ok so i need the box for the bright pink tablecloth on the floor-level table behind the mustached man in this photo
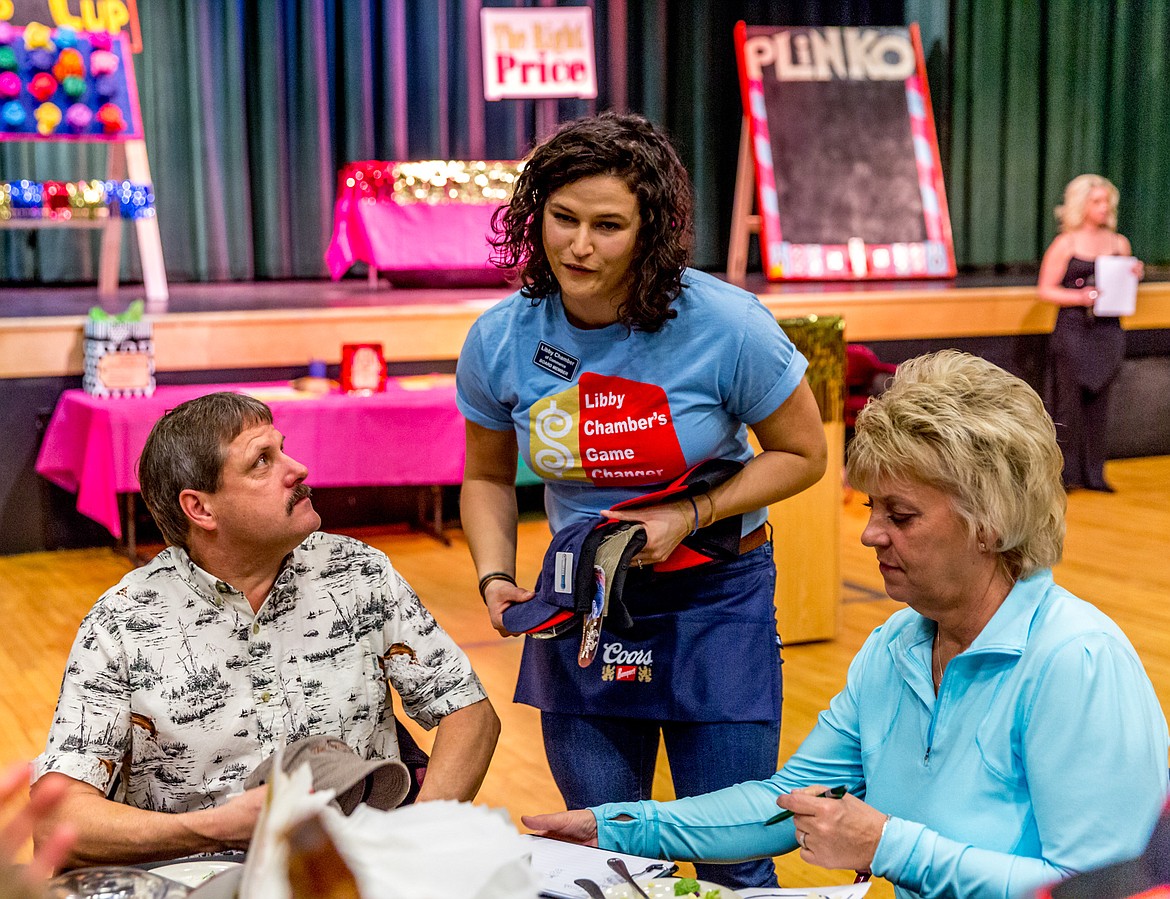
[36,375,464,537]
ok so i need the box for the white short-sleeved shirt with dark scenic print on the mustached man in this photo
[34,533,487,812]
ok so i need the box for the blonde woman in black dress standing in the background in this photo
[1038,174,1143,493]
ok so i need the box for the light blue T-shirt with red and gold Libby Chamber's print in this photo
[456,269,807,534]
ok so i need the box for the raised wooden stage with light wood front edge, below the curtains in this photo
[0,266,1170,379]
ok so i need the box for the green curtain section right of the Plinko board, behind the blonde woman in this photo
[950,0,1170,266]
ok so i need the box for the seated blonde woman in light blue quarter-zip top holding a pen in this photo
[524,351,1168,899]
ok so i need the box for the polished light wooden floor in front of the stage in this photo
[0,457,1170,897]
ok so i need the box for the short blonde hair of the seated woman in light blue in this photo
[846,350,1066,579]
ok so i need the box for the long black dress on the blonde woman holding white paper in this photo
[1048,256,1126,490]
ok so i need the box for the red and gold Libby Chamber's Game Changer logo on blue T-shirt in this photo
[529,372,686,487]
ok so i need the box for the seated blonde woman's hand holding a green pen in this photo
[776,785,887,871]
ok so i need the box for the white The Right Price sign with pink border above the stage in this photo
[480,6,597,99]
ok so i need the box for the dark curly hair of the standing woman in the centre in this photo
[490,112,695,331]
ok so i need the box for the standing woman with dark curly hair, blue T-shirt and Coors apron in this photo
[457,114,826,886]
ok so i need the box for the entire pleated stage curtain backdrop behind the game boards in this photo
[0,0,1170,282]
